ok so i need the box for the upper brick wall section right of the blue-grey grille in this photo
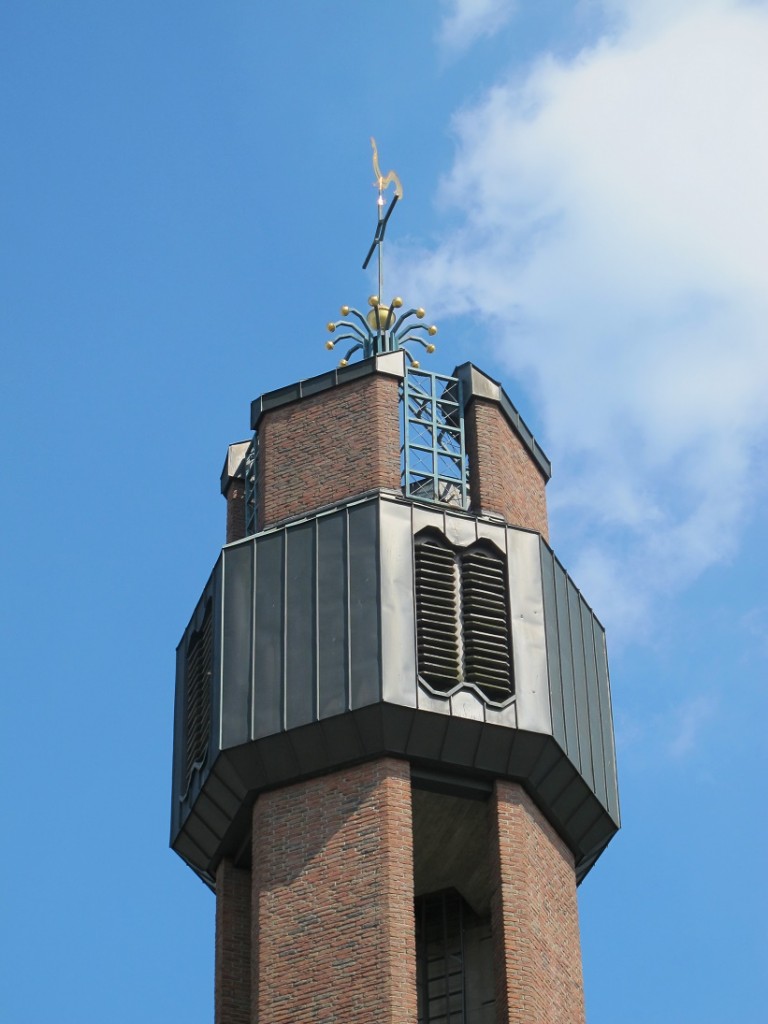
[465,398,549,539]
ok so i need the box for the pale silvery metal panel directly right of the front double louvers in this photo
[507,529,552,733]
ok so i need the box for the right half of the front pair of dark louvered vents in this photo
[462,549,512,700]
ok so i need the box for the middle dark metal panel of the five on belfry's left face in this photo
[286,520,316,729]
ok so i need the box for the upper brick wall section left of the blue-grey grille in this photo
[258,374,400,528]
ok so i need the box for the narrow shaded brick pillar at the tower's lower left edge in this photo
[214,859,251,1024]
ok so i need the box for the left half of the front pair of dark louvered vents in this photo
[416,541,461,689]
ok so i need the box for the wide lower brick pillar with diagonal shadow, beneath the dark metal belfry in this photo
[253,759,417,1024]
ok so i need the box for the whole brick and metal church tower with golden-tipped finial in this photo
[171,149,620,1024]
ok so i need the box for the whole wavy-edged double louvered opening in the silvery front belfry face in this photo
[414,530,514,701]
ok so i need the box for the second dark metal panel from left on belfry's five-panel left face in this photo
[253,530,285,739]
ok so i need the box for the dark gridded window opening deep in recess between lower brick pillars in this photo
[416,889,466,1024]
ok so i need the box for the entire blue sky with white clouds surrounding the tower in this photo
[0,0,768,1024]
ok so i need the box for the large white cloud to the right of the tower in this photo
[408,0,768,631]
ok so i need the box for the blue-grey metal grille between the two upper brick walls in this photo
[402,368,468,508]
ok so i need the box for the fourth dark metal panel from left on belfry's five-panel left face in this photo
[317,512,348,718]
